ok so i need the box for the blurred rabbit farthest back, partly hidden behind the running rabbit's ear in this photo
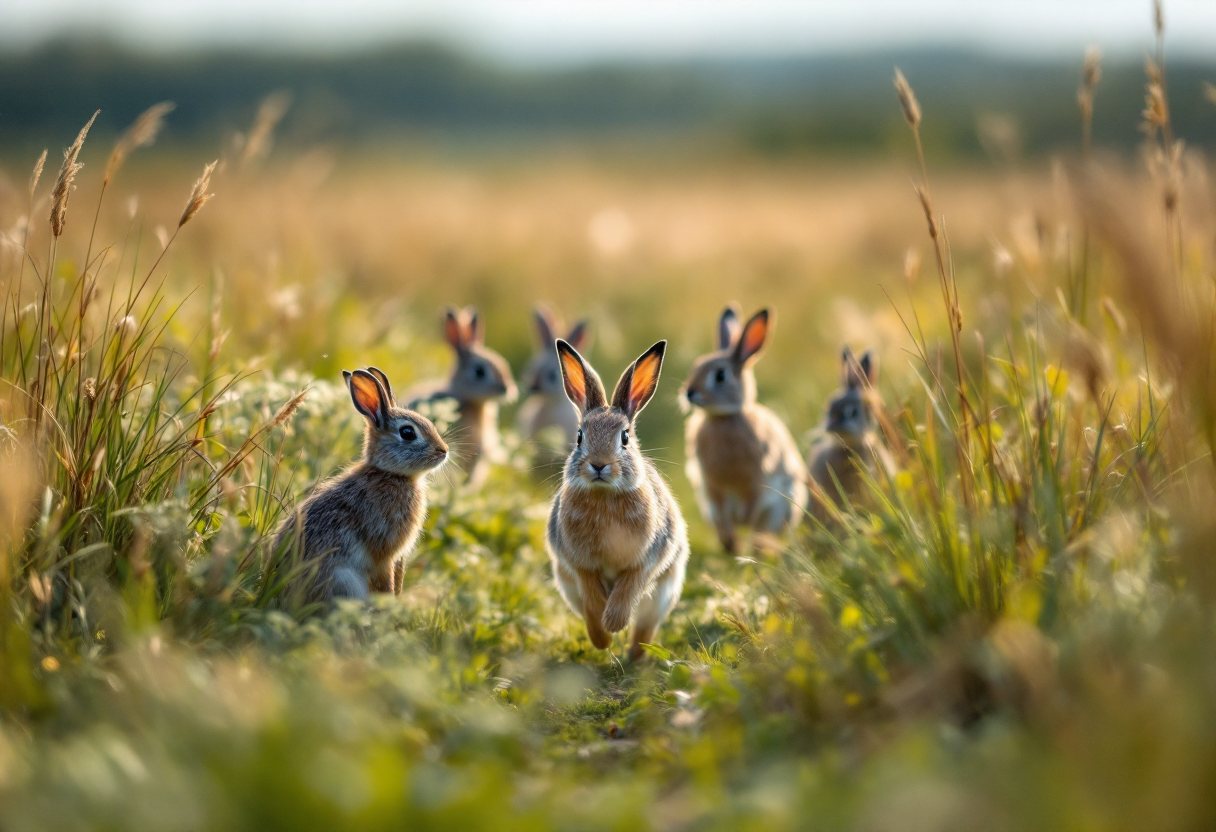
[516,305,587,459]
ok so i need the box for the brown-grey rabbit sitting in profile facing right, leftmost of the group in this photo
[275,367,447,601]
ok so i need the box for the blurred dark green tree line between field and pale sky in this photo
[0,40,1216,158]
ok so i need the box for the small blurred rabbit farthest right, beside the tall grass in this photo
[807,345,895,519]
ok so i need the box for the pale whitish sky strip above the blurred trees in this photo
[0,0,1216,63]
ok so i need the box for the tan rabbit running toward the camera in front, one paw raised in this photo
[546,341,688,659]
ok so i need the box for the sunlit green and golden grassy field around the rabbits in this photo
[0,48,1216,831]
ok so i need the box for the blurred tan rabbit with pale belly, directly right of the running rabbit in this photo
[681,305,806,555]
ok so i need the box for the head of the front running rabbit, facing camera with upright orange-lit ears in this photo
[557,339,668,491]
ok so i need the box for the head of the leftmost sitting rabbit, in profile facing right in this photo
[342,367,447,477]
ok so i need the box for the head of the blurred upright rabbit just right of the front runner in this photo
[680,304,772,416]
